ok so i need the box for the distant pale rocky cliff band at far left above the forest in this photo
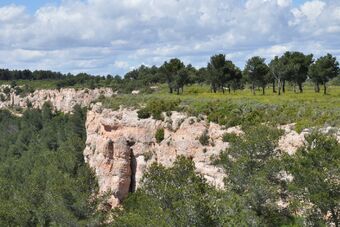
[0,86,113,113]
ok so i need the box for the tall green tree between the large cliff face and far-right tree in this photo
[216,125,295,226]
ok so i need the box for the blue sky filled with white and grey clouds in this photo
[0,0,340,75]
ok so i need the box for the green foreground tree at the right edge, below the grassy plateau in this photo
[284,133,340,226]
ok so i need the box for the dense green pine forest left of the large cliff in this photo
[0,104,106,226]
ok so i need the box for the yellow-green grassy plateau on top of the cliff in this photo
[101,85,340,131]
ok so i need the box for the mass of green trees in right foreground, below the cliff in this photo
[112,126,340,226]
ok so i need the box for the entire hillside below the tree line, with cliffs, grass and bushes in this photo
[0,81,340,226]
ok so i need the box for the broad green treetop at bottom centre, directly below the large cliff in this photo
[112,157,260,226]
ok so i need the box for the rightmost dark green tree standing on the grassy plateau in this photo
[309,54,339,94]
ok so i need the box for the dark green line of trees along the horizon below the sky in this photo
[0,52,340,95]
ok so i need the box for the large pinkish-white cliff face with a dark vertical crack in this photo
[84,104,228,207]
